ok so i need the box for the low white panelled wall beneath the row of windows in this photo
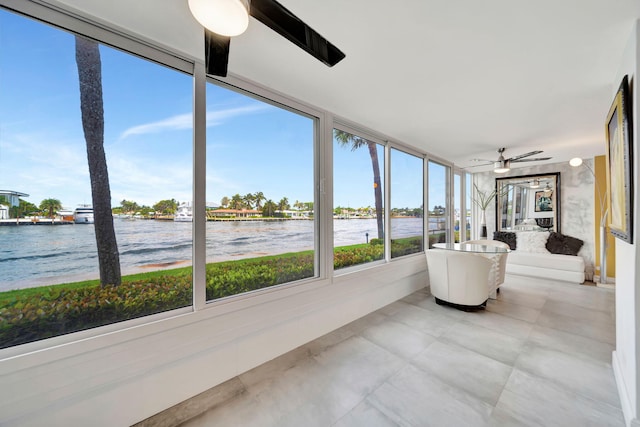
[0,254,427,427]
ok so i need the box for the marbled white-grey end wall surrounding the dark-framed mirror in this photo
[474,161,596,266]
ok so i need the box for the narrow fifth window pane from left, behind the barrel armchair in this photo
[428,161,449,248]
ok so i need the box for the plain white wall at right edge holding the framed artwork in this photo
[611,18,640,426]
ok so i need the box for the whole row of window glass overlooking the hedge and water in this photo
[0,2,449,348]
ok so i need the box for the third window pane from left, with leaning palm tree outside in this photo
[333,129,384,270]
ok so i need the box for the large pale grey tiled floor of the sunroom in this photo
[178,276,624,427]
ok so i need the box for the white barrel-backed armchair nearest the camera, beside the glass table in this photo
[425,249,493,311]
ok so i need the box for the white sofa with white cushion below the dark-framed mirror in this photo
[494,231,585,284]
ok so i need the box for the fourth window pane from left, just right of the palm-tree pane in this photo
[391,149,424,258]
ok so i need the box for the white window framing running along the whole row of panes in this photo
[0,0,453,358]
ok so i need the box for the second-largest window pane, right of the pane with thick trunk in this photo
[207,83,316,301]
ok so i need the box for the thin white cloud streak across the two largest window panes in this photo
[119,104,271,140]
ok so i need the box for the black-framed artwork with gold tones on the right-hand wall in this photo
[605,76,633,243]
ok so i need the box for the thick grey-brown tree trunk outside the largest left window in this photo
[76,36,122,286]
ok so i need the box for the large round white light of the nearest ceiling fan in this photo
[189,0,249,37]
